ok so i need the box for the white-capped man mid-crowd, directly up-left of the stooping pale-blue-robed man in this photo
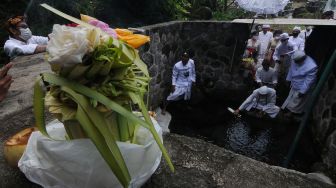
[273,33,298,74]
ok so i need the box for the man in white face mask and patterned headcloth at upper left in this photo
[4,16,48,59]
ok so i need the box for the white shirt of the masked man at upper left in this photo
[4,36,48,58]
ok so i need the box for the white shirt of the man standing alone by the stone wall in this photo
[172,59,196,86]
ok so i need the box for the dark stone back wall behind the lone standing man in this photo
[140,21,249,108]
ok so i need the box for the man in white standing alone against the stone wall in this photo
[162,53,196,114]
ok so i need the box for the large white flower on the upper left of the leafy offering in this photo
[47,24,93,67]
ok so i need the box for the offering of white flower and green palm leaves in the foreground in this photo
[30,4,174,187]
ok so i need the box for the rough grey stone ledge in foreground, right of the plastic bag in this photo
[143,134,334,188]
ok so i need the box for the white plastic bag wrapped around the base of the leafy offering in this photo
[18,119,162,188]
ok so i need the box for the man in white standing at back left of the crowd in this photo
[258,25,273,59]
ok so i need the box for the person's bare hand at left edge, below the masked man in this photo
[0,63,13,102]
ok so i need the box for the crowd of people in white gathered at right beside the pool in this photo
[235,25,318,118]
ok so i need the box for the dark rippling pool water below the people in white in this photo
[168,101,318,172]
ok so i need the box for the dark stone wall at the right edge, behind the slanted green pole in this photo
[306,26,336,180]
